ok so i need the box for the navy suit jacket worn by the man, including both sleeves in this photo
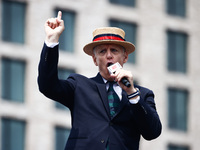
[38,44,161,150]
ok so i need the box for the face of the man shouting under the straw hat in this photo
[92,44,128,80]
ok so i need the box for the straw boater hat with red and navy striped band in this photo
[83,27,135,56]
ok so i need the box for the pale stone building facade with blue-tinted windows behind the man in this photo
[0,0,200,150]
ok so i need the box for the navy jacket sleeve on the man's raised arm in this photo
[38,44,75,107]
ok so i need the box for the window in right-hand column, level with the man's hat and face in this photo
[167,31,188,73]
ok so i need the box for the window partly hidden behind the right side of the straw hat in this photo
[110,20,137,64]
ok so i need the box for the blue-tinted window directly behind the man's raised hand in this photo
[55,9,75,53]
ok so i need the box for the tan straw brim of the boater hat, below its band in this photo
[83,40,135,56]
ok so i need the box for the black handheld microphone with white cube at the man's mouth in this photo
[107,62,131,87]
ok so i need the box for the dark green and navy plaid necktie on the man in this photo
[108,81,120,117]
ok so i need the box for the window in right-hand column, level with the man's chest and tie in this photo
[168,88,188,131]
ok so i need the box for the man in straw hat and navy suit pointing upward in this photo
[38,11,161,150]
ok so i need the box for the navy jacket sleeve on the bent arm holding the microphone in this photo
[132,88,162,140]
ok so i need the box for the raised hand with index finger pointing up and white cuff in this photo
[44,11,65,43]
